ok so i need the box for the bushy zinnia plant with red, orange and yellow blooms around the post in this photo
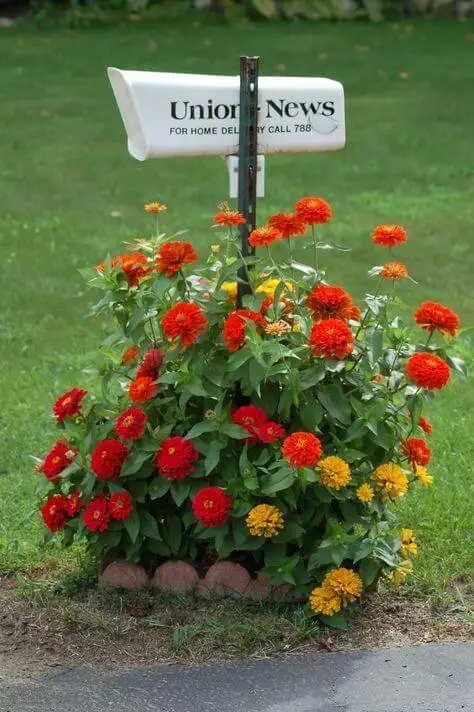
[37,197,463,625]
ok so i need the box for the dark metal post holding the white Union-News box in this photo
[237,56,260,308]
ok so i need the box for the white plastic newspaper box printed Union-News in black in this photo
[108,67,345,161]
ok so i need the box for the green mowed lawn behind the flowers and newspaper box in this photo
[0,22,474,596]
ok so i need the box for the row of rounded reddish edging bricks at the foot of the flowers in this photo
[99,559,293,601]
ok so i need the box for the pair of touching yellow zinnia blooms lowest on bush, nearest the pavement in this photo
[309,568,362,616]
